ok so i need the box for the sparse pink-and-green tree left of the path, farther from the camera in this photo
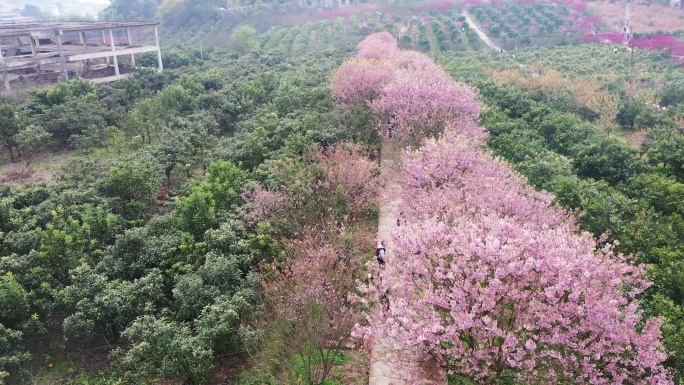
[245,143,378,239]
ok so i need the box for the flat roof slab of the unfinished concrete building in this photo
[0,21,159,38]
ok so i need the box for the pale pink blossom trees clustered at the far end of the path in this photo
[331,32,481,137]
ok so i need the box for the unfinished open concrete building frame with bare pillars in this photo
[0,21,163,91]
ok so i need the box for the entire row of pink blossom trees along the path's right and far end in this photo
[331,33,672,384]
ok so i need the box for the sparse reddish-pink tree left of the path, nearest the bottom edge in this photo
[264,228,368,384]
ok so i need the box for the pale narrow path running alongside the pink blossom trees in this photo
[369,139,447,385]
